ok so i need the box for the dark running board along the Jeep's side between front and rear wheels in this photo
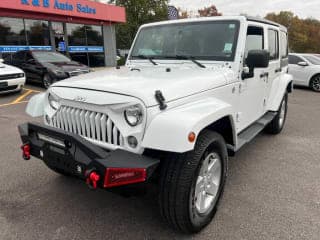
[228,112,277,152]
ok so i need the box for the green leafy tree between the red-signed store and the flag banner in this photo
[109,0,168,49]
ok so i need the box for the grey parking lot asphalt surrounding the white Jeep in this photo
[0,86,320,240]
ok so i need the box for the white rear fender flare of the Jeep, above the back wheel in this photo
[268,74,293,112]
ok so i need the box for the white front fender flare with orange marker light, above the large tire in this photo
[142,98,233,153]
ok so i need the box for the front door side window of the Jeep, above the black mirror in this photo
[245,26,264,57]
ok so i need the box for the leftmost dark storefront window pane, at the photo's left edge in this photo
[0,17,26,46]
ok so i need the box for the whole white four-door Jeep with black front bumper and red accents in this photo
[19,16,292,233]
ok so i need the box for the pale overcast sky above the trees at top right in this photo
[170,0,320,20]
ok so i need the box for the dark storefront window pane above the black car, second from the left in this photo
[25,19,51,46]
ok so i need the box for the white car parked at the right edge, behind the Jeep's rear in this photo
[289,53,320,92]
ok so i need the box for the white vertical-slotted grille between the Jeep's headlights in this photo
[51,106,124,146]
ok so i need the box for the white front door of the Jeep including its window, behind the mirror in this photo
[236,25,268,131]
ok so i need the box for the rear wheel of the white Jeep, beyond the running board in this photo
[265,93,288,135]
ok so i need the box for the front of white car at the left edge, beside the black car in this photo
[0,59,26,94]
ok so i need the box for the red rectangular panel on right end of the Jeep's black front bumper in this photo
[104,168,147,188]
